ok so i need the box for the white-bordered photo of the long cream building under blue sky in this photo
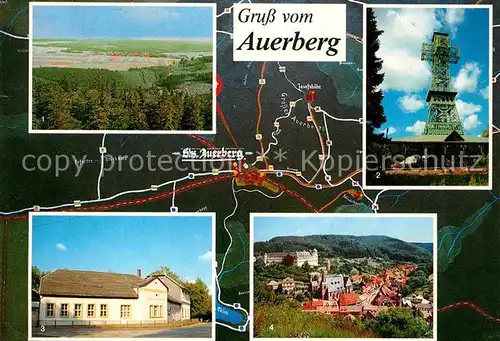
[28,212,215,341]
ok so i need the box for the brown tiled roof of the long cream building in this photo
[40,270,146,298]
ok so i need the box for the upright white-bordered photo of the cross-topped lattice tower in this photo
[363,5,493,189]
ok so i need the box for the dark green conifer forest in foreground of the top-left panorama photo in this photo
[32,61,213,130]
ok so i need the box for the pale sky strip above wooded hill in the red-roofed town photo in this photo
[254,215,434,243]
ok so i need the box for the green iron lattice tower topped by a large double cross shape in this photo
[421,32,464,135]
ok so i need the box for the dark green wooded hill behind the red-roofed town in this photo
[254,235,432,263]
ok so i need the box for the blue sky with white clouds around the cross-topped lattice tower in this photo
[374,8,491,137]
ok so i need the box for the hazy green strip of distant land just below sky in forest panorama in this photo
[33,38,213,56]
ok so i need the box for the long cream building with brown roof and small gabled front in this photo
[40,270,176,325]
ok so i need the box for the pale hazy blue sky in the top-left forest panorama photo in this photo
[33,6,214,39]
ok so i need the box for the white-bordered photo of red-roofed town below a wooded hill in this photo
[250,213,437,340]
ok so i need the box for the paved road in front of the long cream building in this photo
[33,323,212,339]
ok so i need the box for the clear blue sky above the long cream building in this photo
[32,216,212,287]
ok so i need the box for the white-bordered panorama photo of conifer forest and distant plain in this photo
[29,2,216,134]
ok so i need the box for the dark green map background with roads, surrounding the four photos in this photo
[0,0,500,341]
